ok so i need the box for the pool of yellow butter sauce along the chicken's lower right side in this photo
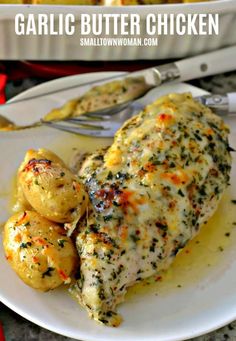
[126,189,236,300]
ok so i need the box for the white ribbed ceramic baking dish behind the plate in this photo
[0,0,236,60]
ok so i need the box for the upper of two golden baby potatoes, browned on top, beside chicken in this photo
[18,149,88,223]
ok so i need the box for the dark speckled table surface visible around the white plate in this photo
[0,72,236,341]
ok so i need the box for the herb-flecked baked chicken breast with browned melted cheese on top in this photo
[72,94,231,326]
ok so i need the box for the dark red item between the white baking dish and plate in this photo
[0,61,165,104]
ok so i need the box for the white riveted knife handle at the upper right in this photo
[174,45,236,82]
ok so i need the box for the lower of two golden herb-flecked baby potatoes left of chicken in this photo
[3,211,77,291]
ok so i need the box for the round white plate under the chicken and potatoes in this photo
[0,74,236,341]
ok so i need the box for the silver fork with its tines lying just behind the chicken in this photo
[41,92,236,137]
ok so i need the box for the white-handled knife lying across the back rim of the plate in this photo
[0,45,236,108]
